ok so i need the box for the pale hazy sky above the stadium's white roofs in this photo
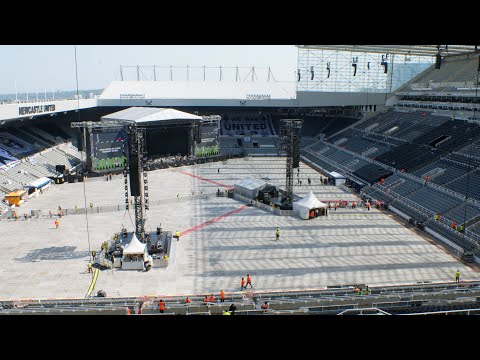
[0,45,297,94]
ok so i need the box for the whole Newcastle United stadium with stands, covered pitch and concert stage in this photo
[0,45,480,316]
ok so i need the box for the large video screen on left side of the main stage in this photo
[91,128,127,171]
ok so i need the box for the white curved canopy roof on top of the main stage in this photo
[101,107,202,125]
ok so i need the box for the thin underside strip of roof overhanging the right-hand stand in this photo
[297,45,478,56]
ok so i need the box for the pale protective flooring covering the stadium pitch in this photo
[0,157,478,299]
